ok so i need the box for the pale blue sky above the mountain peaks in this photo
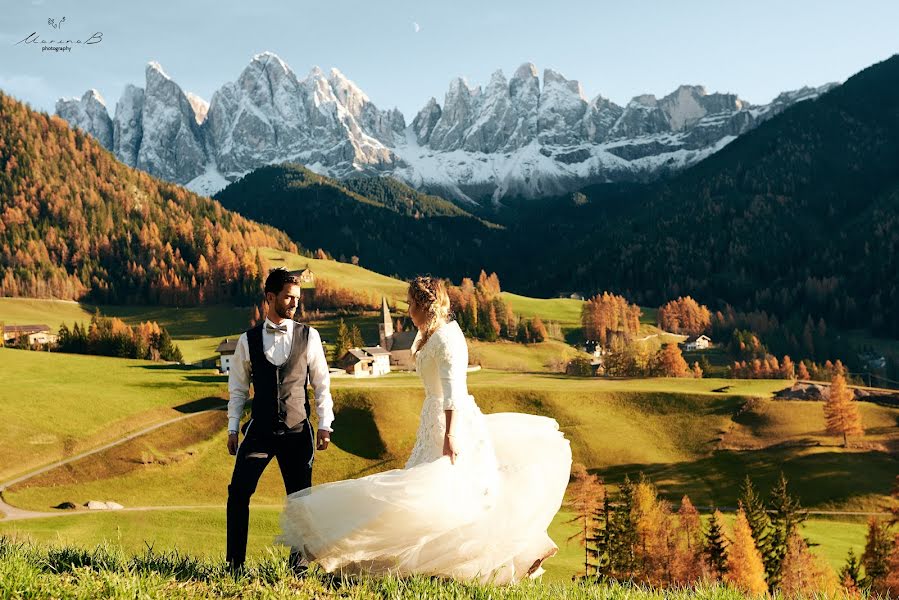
[0,0,899,121]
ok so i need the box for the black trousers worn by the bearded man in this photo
[226,420,315,565]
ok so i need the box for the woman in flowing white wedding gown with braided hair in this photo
[278,277,571,583]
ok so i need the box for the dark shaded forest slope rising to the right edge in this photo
[504,56,899,335]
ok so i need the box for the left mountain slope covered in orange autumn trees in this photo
[0,93,296,304]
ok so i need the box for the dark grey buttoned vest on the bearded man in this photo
[247,321,309,433]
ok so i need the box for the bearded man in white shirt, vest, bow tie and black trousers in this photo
[226,267,334,574]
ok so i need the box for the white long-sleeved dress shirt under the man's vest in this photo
[228,319,334,431]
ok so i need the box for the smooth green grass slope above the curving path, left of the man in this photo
[0,348,226,480]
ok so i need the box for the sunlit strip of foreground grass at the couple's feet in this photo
[0,537,820,600]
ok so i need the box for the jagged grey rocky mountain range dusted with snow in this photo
[56,52,835,203]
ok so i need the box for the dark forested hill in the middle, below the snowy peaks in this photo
[215,163,497,279]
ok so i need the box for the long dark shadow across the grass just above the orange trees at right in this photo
[597,448,899,508]
